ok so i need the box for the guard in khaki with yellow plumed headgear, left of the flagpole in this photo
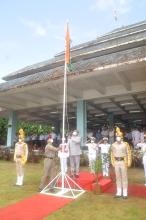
[14,129,28,186]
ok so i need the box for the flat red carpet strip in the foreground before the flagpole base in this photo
[0,194,72,220]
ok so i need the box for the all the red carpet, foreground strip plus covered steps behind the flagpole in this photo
[0,172,146,220]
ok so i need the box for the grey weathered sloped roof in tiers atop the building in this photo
[0,21,146,91]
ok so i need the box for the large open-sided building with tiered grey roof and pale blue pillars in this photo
[0,21,146,146]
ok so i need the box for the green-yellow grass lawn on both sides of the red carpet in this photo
[0,161,146,220]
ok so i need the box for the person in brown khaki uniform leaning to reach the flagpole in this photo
[39,137,60,191]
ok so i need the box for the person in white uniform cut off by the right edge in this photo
[137,133,146,186]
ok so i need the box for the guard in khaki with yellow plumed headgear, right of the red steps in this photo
[111,127,131,199]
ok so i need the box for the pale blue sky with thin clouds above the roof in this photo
[0,0,146,82]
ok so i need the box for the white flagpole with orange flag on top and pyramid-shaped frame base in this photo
[41,23,85,198]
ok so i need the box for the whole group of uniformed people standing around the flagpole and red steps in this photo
[14,127,146,198]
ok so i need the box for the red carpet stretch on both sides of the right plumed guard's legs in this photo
[105,184,146,198]
